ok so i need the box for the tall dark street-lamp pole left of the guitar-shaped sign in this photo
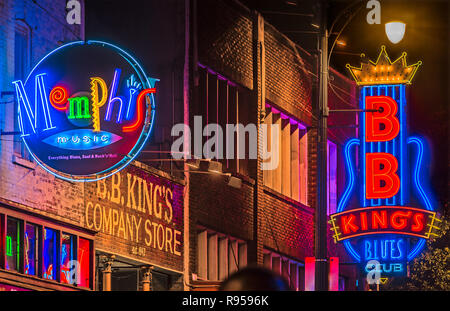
[315,0,328,291]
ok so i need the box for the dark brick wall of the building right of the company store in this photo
[190,1,356,290]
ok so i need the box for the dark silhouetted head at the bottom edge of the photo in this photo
[219,267,290,291]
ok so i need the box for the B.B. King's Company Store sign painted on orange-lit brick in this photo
[83,164,184,271]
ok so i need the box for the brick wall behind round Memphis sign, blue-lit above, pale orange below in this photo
[0,0,83,224]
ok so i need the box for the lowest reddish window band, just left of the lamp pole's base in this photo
[263,249,304,291]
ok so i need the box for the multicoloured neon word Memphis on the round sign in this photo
[13,68,156,143]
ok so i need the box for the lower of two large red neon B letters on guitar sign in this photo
[366,152,400,199]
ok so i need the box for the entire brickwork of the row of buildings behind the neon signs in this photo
[0,0,356,290]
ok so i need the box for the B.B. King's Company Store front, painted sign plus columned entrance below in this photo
[84,165,183,291]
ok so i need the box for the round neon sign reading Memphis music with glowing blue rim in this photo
[13,41,158,181]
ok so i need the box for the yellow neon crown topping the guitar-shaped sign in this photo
[346,45,422,85]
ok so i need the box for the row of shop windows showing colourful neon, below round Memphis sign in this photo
[0,213,93,288]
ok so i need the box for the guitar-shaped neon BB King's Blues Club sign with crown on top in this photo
[330,46,440,275]
